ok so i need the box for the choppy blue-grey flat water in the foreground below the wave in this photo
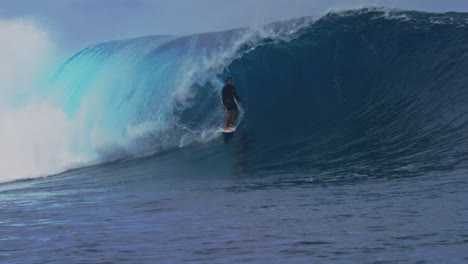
[0,143,468,263]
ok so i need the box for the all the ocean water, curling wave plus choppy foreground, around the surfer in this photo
[0,9,468,263]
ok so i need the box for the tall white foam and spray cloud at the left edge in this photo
[0,20,85,182]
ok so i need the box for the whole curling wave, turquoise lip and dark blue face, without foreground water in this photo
[0,9,468,182]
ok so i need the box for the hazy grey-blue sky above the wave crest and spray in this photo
[0,0,468,52]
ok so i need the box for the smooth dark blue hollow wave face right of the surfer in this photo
[229,9,468,179]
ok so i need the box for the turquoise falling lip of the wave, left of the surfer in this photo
[42,18,311,161]
